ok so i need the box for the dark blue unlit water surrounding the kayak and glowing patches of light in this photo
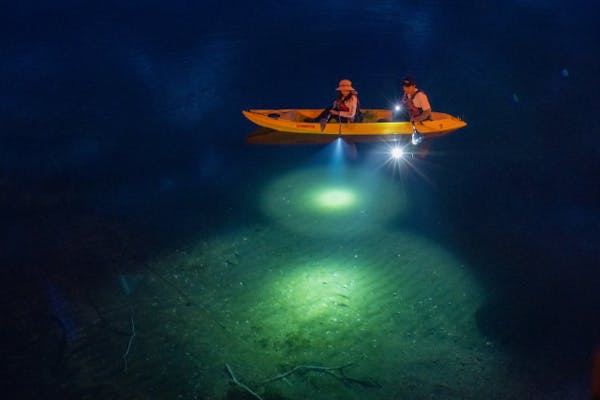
[0,0,600,393]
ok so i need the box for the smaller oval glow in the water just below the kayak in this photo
[261,168,407,237]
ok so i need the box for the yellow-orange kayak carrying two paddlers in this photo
[242,109,467,136]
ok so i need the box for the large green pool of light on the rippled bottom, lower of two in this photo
[154,225,492,398]
